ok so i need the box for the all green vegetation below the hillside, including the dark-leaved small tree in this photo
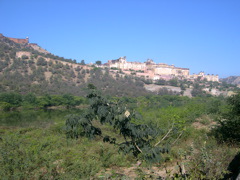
[0,89,239,179]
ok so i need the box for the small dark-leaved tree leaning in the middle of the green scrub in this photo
[66,84,183,163]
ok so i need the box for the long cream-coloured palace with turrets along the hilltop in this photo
[104,57,219,82]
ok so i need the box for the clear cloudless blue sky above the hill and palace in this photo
[0,0,240,78]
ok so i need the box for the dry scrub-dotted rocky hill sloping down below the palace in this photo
[0,34,239,97]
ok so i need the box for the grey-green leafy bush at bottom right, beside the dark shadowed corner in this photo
[186,139,235,179]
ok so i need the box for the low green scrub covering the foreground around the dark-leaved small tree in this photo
[0,88,240,179]
